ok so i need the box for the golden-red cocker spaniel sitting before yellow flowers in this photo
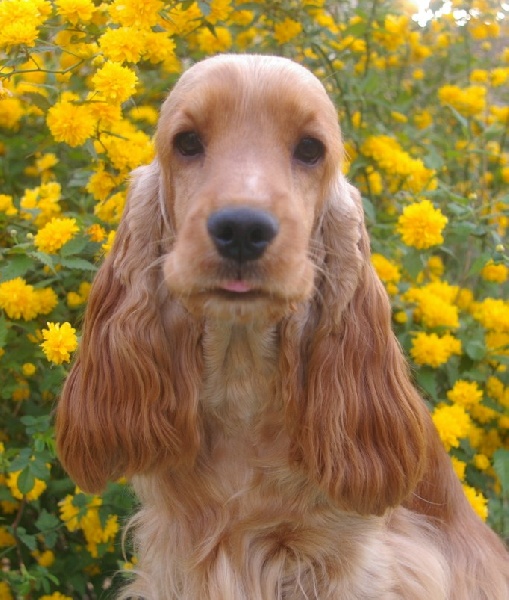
[56,55,509,600]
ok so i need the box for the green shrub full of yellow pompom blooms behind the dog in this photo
[0,0,509,600]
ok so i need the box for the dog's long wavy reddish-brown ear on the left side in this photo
[56,161,201,492]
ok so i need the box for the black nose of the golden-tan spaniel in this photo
[207,208,279,262]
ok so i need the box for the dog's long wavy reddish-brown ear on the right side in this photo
[281,176,429,514]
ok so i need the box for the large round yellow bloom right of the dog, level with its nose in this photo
[397,200,447,250]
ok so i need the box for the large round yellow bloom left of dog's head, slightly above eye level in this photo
[46,100,96,148]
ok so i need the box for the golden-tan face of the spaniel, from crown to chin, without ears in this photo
[157,57,342,320]
